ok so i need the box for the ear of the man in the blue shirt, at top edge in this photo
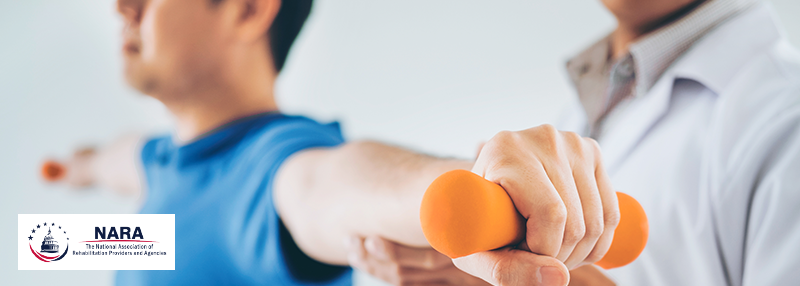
[227,0,282,42]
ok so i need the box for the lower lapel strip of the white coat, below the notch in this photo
[598,72,675,174]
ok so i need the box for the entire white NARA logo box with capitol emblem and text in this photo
[17,214,175,270]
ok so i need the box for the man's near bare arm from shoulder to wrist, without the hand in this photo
[273,141,473,265]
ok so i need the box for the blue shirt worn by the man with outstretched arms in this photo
[116,113,352,285]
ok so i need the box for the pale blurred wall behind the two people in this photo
[0,0,800,286]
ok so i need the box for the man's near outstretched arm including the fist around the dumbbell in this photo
[274,125,619,285]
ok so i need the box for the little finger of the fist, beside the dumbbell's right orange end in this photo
[586,152,620,263]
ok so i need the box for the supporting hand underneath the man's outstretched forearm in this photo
[348,236,488,285]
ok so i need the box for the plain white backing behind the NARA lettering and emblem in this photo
[17,214,175,270]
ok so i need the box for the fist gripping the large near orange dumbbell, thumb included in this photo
[454,125,619,285]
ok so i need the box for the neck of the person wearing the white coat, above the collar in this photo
[609,0,706,59]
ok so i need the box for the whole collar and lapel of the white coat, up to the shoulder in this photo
[598,3,781,172]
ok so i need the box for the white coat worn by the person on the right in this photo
[560,4,800,286]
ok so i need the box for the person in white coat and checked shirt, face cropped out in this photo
[352,0,800,286]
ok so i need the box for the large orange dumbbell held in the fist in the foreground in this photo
[420,170,648,269]
